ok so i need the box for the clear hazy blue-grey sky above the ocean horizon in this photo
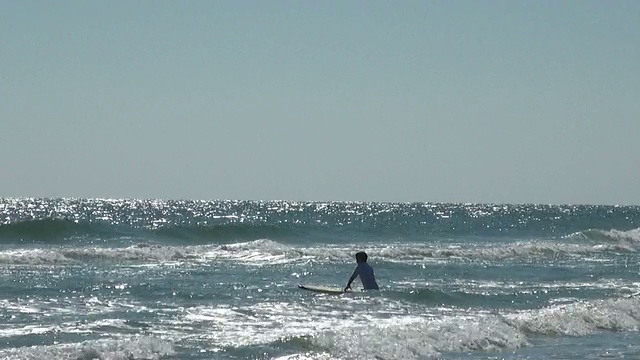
[0,0,640,205]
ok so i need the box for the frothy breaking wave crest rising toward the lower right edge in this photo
[313,298,640,359]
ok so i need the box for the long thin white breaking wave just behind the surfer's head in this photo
[0,232,640,265]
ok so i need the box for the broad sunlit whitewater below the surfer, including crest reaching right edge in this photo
[158,290,640,359]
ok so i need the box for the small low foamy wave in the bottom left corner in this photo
[0,337,175,360]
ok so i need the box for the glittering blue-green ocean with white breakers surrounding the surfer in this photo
[0,199,640,360]
